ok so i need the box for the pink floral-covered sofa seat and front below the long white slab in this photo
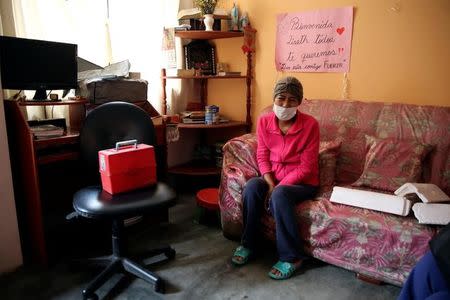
[262,200,437,286]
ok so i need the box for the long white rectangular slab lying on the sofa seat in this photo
[330,186,411,216]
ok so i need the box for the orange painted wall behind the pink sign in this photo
[208,0,450,127]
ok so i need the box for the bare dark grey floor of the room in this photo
[0,194,400,300]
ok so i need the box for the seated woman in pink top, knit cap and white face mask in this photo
[232,77,319,279]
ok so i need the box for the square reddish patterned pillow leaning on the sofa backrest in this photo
[352,135,432,192]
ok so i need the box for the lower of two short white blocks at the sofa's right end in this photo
[413,202,450,225]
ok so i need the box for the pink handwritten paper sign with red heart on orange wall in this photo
[275,6,353,72]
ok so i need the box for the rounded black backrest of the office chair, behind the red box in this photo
[80,101,158,173]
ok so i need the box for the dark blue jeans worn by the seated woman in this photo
[242,177,317,262]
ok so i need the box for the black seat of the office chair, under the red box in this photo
[73,182,176,219]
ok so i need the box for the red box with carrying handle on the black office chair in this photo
[98,140,156,194]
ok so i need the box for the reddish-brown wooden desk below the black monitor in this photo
[4,100,85,264]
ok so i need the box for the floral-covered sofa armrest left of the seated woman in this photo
[219,134,259,239]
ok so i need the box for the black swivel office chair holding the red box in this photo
[72,102,176,299]
